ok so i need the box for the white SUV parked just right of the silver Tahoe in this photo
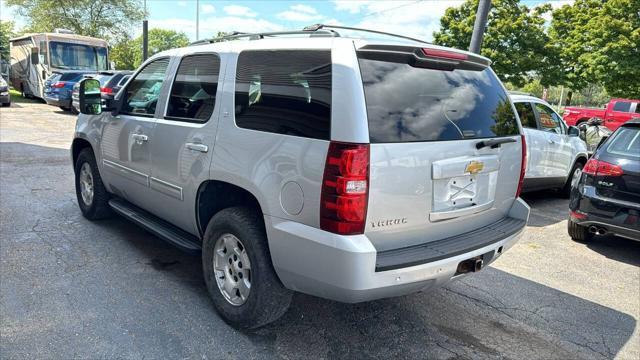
[511,94,588,196]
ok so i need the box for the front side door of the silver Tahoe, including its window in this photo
[101,58,169,208]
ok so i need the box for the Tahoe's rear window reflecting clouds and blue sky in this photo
[359,58,519,143]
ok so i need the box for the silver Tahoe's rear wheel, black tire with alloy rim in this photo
[202,207,293,329]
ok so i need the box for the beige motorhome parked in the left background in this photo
[9,29,110,98]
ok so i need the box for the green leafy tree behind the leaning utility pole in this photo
[433,0,557,86]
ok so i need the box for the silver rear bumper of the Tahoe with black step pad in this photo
[265,199,529,303]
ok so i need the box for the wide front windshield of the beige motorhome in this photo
[49,41,108,71]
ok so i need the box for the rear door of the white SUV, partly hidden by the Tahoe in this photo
[514,102,550,179]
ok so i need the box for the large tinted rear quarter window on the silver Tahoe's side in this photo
[235,50,331,140]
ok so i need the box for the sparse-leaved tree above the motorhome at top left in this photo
[6,0,144,40]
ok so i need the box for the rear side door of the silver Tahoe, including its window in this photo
[144,53,225,234]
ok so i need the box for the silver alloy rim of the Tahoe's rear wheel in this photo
[213,234,251,306]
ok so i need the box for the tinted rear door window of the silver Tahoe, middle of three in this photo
[166,54,220,122]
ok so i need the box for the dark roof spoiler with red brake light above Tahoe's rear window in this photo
[357,45,491,71]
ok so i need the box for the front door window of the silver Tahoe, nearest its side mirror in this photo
[122,59,169,117]
